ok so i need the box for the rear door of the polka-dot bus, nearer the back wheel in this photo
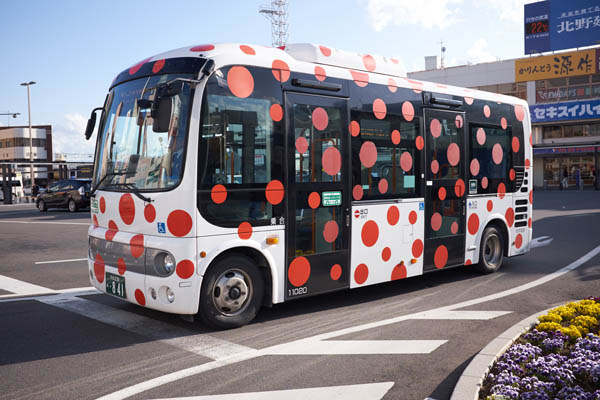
[423,109,466,271]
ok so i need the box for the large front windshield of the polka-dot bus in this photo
[94,74,192,190]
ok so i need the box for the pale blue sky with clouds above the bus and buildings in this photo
[0,0,531,161]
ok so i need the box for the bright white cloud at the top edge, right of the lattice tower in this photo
[367,0,463,32]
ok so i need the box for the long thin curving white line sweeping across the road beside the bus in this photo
[99,246,600,400]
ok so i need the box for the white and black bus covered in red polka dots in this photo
[86,44,533,328]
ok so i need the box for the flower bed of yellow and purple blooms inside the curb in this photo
[479,298,600,400]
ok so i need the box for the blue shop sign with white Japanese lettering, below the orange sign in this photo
[529,100,600,123]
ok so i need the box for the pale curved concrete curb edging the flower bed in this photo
[450,306,556,400]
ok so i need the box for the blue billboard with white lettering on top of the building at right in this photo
[525,0,600,54]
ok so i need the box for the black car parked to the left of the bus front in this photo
[36,179,91,212]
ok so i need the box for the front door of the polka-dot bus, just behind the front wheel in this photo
[285,92,351,299]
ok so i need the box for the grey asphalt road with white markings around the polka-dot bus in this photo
[0,192,600,400]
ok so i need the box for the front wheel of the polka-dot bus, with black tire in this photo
[198,255,264,329]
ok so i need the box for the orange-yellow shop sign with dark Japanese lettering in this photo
[515,48,600,82]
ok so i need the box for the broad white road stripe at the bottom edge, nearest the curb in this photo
[152,382,394,400]
